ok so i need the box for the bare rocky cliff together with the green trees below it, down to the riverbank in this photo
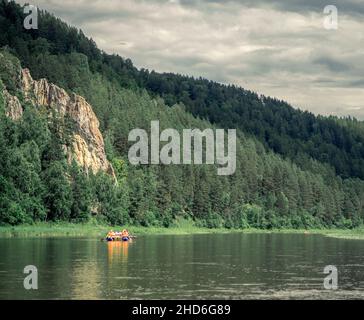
[0,51,123,225]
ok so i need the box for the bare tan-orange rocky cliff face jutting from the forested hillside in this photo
[4,69,115,177]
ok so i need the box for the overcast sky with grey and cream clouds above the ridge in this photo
[18,0,364,119]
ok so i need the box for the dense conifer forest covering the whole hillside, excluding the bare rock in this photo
[0,0,364,228]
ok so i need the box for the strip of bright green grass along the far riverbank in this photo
[0,221,364,240]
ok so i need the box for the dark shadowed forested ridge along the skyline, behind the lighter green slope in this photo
[0,0,364,179]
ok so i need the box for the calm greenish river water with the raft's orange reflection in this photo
[0,234,364,299]
